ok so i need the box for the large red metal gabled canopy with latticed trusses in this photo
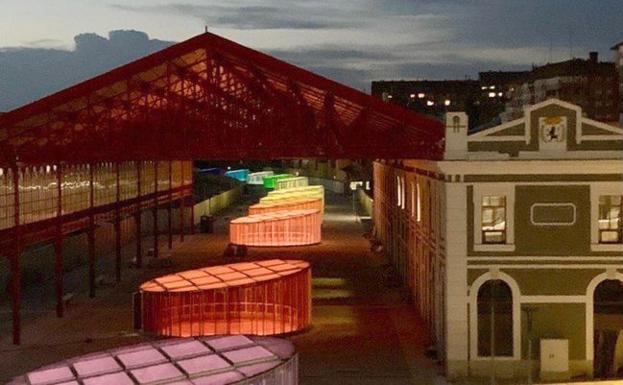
[0,33,442,166]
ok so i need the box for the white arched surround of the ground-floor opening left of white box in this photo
[468,267,521,361]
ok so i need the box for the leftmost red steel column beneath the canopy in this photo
[11,165,22,345]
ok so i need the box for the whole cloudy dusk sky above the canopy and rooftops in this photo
[0,0,623,111]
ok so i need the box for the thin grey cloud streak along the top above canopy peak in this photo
[112,3,353,29]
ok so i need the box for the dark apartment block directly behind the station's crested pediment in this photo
[501,52,620,122]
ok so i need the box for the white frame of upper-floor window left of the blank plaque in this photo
[473,183,515,251]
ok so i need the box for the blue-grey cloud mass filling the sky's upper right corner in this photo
[376,0,623,55]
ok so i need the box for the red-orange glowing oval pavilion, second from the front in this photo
[140,259,311,337]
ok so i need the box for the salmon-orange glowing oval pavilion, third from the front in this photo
[229,210,322,246]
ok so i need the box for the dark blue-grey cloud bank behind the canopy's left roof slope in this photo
[0,31,172,111]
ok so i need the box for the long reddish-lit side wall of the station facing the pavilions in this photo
[373,162,446,359]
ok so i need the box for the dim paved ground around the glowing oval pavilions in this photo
[0,190,444,385]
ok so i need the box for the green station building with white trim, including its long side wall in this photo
[374,99,623,380]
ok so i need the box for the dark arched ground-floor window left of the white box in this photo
[477,279,513,357]
